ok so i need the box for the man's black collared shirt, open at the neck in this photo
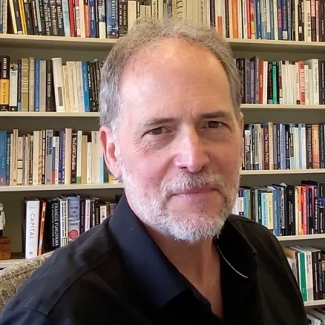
[0,196,307,325]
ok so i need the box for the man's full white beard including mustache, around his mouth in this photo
[116,140,241,244]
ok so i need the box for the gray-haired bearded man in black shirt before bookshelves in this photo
[0,21,307,325]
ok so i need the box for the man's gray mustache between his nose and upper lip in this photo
[161,170,228,196]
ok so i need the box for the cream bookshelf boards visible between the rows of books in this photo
[0,1,325,316]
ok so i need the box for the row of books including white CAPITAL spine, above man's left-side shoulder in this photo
[22,195,120,258]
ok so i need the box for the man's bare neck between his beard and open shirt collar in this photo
[148,225,219,287]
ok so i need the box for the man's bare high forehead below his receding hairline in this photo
[120,39,232,114]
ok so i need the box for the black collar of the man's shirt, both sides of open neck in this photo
[109,194,256,309]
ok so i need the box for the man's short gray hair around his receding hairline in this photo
[99,19,241,132]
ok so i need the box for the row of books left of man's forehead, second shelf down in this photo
[0,55,103,113]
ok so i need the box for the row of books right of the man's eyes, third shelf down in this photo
[242,122,325,170]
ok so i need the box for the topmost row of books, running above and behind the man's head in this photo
[0,0,325,42]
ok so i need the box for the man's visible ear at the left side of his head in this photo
[99,126,122,178]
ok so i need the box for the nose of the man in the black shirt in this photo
[174,130,209,173]
